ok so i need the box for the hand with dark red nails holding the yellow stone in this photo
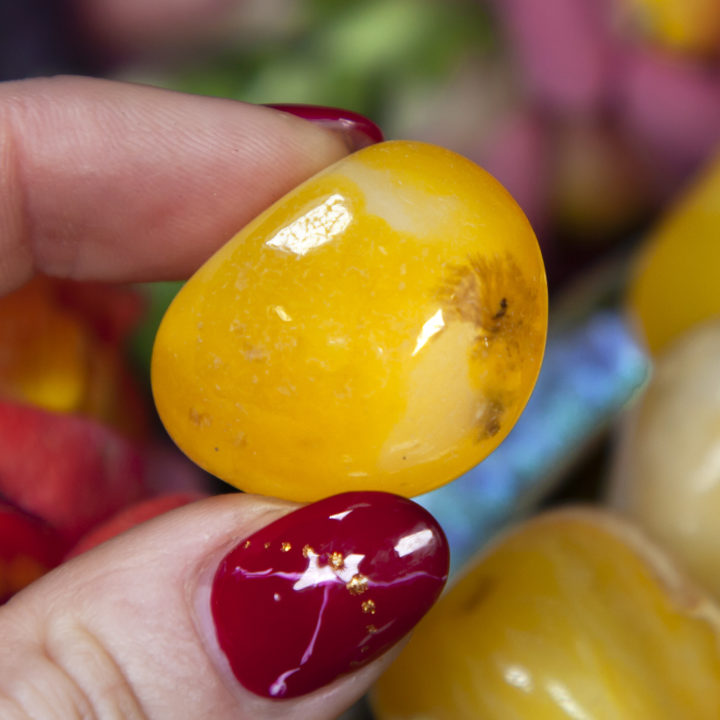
[0,78,447,720]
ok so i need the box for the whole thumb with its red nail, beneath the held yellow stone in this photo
[0,492,448,720]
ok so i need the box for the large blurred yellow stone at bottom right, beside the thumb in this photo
[372,510,720,720]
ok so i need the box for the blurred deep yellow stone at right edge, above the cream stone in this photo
[628,156,720,353]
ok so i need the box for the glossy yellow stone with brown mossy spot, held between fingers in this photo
[152,142,547,500]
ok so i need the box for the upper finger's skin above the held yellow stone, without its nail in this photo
[0,77,349,294]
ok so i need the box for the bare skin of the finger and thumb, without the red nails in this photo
[0,23,404,720]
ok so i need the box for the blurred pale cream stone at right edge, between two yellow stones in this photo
[609,318,720,599]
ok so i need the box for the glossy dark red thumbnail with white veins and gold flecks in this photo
[211,492,449,699]
